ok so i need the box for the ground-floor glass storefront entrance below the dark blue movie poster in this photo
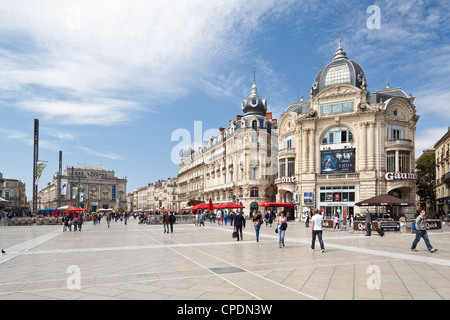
[319,186,356,220]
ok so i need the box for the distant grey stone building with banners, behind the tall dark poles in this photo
[38,164,127,212]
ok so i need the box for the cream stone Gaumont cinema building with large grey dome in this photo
[275,45,419,219]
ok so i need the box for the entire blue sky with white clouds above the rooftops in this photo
[0,0,450,199]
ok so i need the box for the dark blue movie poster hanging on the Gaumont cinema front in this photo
[320,149,355,174]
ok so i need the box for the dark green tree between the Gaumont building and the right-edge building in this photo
[416,153,436,208]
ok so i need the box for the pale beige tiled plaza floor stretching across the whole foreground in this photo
[0,219,450,300]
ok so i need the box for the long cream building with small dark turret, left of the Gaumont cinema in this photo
[178,79,278,211]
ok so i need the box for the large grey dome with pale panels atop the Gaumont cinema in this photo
[311,46,366,95]
